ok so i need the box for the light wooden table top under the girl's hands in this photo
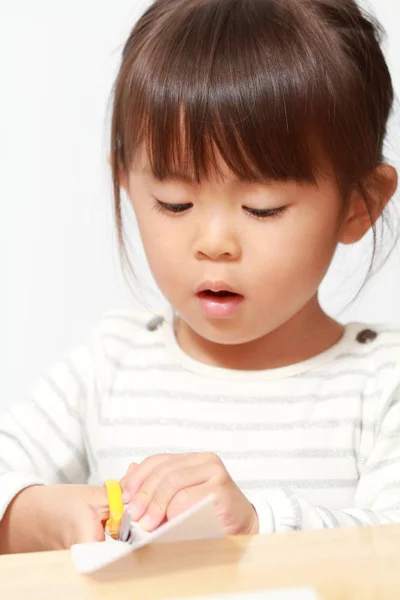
[0,525,400,600]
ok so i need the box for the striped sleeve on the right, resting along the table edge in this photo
[249,385,400,533]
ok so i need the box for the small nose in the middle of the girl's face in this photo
[195,216,241,261]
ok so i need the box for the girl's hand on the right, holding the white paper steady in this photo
[120,452,258,535]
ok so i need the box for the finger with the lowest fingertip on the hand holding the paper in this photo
[137,463,213,531]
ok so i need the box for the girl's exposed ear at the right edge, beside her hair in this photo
[339,164,397,244]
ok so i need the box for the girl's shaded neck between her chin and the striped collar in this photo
[176,296,344,370]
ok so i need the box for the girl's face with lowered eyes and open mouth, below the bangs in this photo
[123,149,341,344]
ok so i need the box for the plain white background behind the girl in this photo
[0,0,400,408]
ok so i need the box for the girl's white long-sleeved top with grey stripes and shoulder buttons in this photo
[0,310,400,532]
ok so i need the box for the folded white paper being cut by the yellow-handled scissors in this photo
[71,495,223,574]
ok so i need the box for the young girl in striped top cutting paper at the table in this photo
[0,0,400,552]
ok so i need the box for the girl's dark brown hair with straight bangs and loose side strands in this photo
[111,0,393,284]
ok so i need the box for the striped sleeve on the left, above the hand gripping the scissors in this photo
[0,346,93,518]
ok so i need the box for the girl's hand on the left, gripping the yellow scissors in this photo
[0,484,109,553]
